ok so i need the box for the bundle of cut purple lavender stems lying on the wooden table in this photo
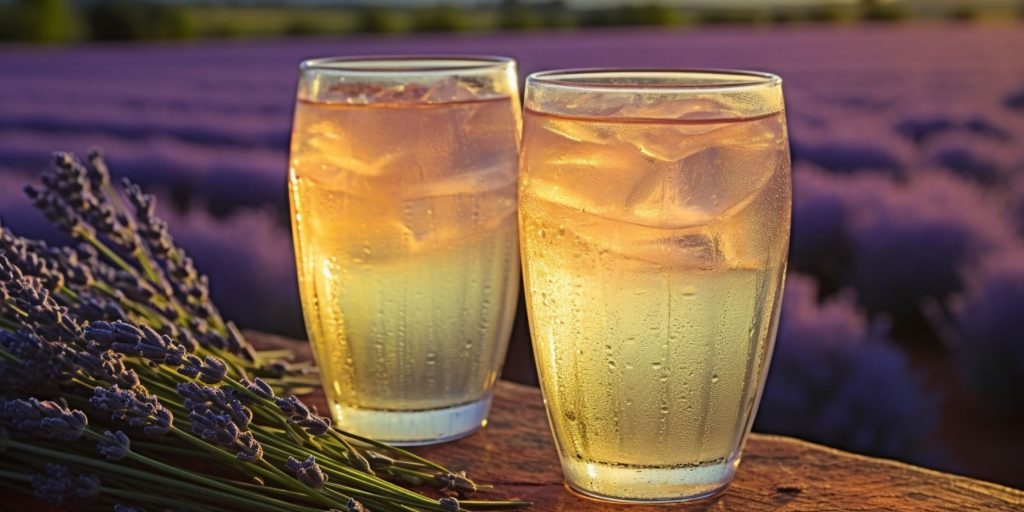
[0,152,529,512]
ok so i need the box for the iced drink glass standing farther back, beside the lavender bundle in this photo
[289,56,521,444]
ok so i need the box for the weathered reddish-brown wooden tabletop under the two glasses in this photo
[245,336,1024,512]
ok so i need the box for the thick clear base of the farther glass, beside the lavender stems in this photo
[335,393,492,446]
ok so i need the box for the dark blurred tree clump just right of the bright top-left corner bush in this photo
[86,0,196,41]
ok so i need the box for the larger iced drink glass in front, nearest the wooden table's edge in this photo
[519,70,792,502]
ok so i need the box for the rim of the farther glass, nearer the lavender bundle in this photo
[299,54,516,77]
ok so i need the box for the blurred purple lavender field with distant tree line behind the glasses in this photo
[0,0,1024,487]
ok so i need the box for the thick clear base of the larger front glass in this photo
[562,457,739,503]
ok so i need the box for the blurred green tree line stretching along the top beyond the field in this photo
[0,0,966,42]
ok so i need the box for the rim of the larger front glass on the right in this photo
[526,68,782,94]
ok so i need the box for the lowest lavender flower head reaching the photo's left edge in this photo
[3,398,88,441]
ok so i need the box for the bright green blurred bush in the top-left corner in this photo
[0,0,80,43]
